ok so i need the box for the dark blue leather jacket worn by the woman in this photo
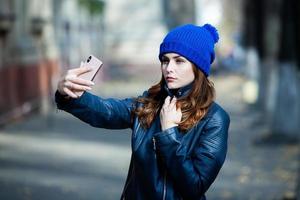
[55,88,230,200]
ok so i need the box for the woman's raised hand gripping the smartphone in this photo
[57,67,94,98]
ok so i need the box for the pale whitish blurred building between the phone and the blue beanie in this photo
[104,0,196,82]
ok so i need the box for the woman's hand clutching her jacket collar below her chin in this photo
[160,96,182,131]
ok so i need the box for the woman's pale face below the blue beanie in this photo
[161,53,195,89]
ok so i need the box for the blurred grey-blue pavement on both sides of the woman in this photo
[0,75,299,200]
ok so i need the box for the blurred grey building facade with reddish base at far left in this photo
[0,0,103,124]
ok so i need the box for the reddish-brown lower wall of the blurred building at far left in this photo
[0,60,59,124]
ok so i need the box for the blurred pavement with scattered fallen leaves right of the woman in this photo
[208,76,300,200]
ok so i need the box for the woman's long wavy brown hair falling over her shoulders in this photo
[134,65,215,132]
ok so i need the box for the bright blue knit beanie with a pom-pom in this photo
[159,24,219,76]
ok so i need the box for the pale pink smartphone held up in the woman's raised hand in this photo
[75,55,103,96]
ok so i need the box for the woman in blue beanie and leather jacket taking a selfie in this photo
[55,24,230,200]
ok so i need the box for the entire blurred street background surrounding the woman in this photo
[0,0,300,200]
